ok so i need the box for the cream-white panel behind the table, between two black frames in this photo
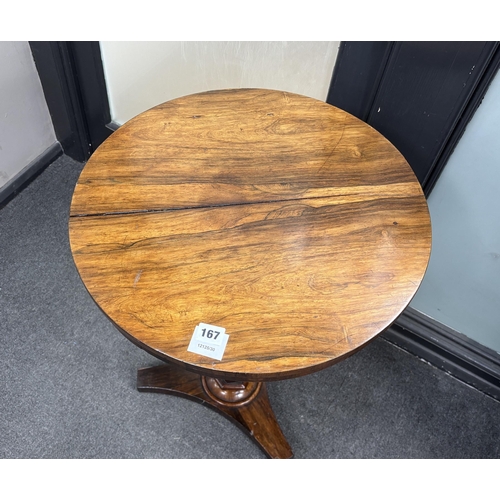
[100,42,339,125]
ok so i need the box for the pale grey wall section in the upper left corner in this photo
[0,42,56,188]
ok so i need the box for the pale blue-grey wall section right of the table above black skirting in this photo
[411,73,500,352]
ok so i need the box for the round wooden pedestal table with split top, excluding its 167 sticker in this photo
[69,89,431,458]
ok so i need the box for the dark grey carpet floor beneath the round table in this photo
[0,156,500,459]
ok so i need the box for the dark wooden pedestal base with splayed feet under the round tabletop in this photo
[137,365,293,458]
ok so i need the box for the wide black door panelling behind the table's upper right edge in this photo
[326,42,500,196]
